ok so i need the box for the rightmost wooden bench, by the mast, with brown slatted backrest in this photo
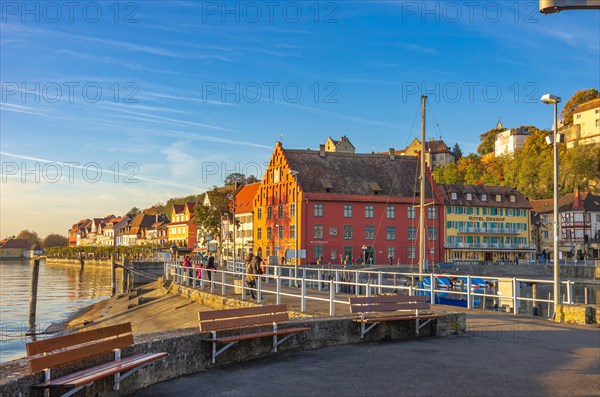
[349,295,442,339]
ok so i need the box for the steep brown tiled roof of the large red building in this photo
[284,149,432,198]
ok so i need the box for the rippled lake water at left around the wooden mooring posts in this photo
[0,260,120,363]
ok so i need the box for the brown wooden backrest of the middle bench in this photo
[198,304,290,332]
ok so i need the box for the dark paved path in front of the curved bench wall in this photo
[135,311,600,397]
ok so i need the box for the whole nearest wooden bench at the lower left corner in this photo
[26,323,167,397]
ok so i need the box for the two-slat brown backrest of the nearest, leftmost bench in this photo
[26,323,133,373]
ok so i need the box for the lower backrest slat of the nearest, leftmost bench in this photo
[29,334,133,373]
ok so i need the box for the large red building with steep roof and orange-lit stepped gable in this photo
[254,142,444,264]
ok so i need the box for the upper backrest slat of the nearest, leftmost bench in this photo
[27,323,131,356]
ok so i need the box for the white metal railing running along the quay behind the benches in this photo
[164,262,588,316]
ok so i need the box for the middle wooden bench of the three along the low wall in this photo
[198,304,310,364]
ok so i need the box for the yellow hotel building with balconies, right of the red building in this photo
[439,185,535,263]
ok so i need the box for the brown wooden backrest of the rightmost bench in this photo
[349,295,431,313]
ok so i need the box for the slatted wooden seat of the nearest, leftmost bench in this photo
[33,353,167,388]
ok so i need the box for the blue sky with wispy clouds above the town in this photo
[0,1,600,237]
